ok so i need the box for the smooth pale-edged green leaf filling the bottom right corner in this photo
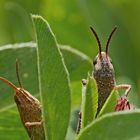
[76,110,140,140]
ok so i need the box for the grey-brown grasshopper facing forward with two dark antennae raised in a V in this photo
[90,27,131,116]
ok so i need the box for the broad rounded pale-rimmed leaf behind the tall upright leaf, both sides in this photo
[0,42,92,140]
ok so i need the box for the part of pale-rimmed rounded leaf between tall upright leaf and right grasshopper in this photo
[59,45,93,108]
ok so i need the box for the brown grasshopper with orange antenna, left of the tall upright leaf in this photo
[0,61,45,140]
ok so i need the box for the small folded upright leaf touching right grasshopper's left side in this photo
[81,75,98,128]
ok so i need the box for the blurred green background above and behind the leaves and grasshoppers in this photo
[0,0,140,110]
